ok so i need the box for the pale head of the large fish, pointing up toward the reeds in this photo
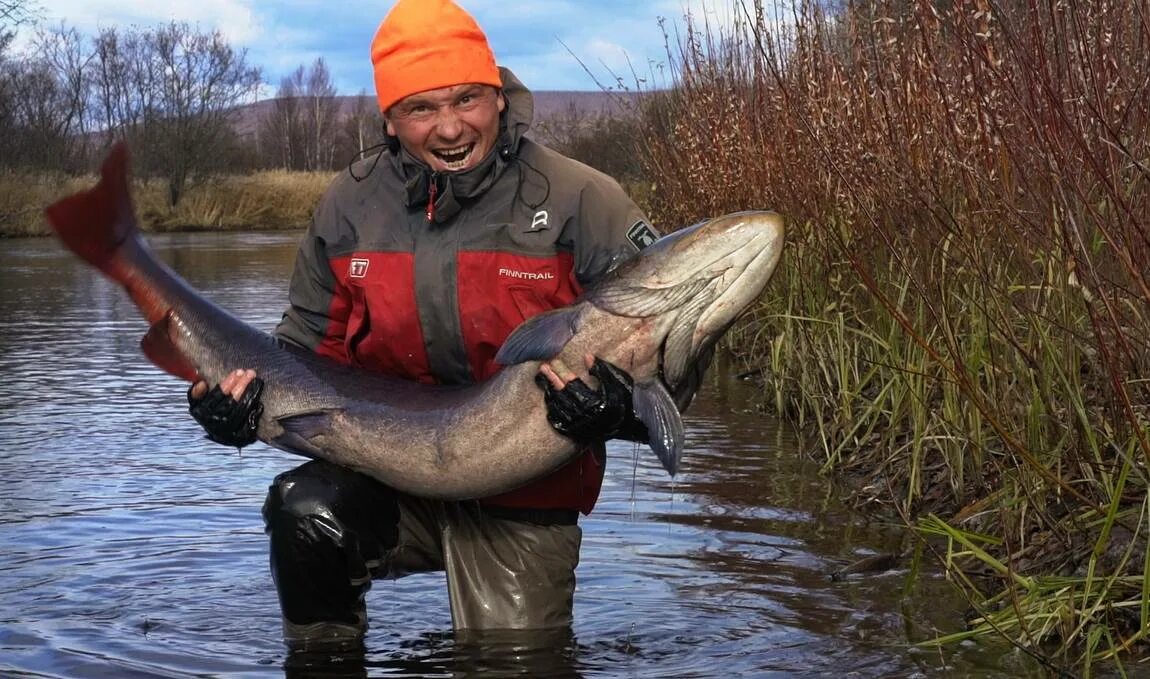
[590,212,784,388]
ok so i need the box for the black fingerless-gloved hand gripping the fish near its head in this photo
[535,358,650,443]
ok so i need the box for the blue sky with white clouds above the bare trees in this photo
[21,0,733,96]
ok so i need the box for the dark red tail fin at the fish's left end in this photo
[45,143,137,280]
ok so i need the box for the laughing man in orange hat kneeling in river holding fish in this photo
[189,0,690,649]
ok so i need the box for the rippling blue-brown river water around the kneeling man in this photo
[0,234,1037,678]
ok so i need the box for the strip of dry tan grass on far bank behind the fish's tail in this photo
[0,171,335,238]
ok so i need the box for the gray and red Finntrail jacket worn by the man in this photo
[276,69,654,513]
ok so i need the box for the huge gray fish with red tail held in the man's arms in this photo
[47,146,783,499]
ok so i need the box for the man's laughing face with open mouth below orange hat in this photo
[384,84,505,173]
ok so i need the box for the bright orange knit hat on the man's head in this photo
[371,0,503,113]
